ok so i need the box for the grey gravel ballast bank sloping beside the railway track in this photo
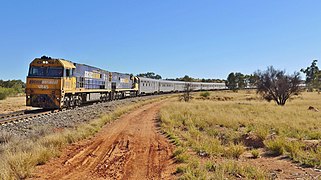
[0,96,159,138]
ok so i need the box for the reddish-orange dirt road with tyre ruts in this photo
[35,102,175,180]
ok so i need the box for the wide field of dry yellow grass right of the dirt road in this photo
[161,91,321,178]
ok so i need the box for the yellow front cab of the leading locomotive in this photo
[26,56,76,109]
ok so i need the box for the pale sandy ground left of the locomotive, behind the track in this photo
[0,96,32,114]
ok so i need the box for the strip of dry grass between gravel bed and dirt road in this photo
[0,97,168,179]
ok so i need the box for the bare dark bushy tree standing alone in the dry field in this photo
[255,66,300,106]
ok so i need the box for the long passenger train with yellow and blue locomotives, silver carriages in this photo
[25,56,227,109]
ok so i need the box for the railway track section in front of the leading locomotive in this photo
[0,109,59,125]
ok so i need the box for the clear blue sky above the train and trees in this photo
[0,0,321,80]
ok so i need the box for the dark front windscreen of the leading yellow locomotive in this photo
[29,66,63,77]
